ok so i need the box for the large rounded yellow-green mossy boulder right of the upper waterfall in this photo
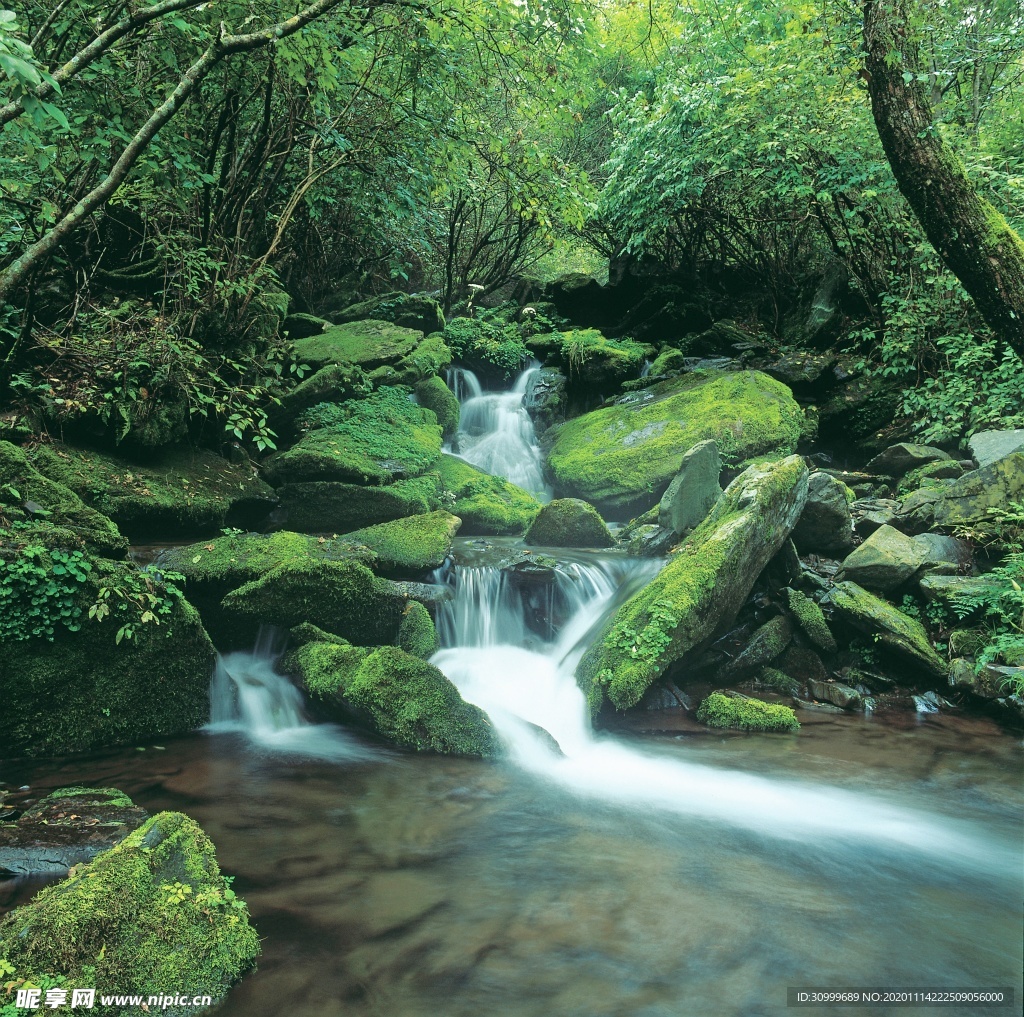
[546,371,804,519]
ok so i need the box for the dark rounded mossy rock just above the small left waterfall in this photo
[221,559,407,646]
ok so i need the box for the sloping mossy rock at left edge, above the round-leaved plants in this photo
[0,441,128,558]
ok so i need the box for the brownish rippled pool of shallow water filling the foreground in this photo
[4,704,1024,1017]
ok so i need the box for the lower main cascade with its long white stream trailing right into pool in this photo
[433,558,1018,872]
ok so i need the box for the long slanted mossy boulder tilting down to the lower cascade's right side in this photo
[577,456,807,713]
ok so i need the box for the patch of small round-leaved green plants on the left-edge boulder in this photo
[0,536,91,643]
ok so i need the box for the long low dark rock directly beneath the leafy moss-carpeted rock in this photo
[278,472,441,534]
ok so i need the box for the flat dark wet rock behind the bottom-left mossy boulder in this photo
[0,788,150,876]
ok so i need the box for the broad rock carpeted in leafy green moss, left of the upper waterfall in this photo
[267,387,441,484]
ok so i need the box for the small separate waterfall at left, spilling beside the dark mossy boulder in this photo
[206,630,378,760]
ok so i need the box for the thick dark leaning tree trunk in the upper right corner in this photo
[864,0,1024,358]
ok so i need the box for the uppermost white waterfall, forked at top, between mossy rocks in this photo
[449,365,551,499]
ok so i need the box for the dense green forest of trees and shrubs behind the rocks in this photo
[0,0,1024,451]
